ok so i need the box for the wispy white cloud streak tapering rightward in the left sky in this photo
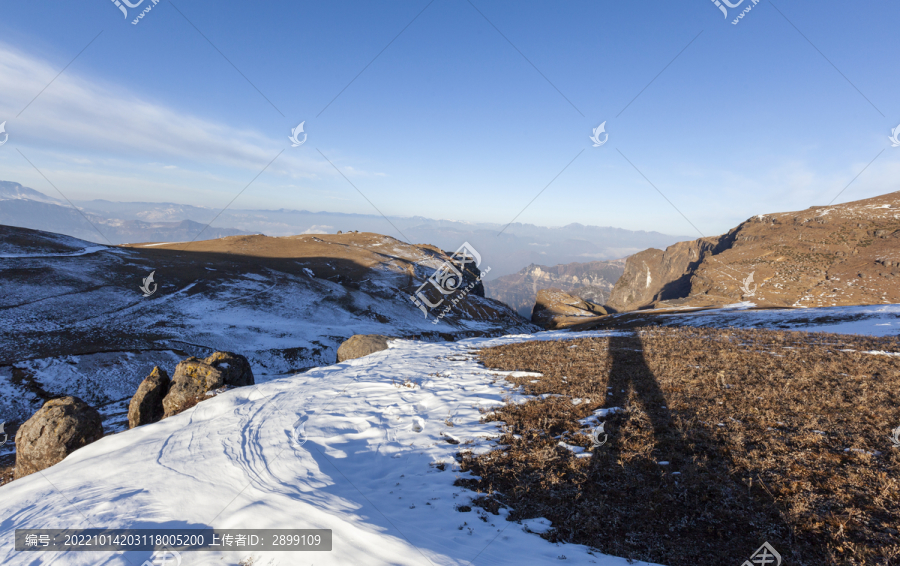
[0,42,377,178]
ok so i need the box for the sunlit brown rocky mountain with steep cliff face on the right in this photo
[607,192,900,311]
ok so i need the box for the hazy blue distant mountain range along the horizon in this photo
[0,181,686,281]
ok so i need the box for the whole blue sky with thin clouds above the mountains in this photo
[0,0,900,236]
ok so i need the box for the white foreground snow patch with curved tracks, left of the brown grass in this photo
[0,332,652,566]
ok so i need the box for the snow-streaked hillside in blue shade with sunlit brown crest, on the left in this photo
[0,227,536,428]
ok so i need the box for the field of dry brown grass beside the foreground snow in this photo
[459,328,900,566]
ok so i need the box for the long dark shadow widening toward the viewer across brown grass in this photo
[582,333,784,566]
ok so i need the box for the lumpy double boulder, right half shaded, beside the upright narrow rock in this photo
[163,352,255,418]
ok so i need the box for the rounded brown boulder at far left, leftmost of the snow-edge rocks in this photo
[15,397,103,479]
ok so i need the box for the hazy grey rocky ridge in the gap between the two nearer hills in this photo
[485,259,625,318]
